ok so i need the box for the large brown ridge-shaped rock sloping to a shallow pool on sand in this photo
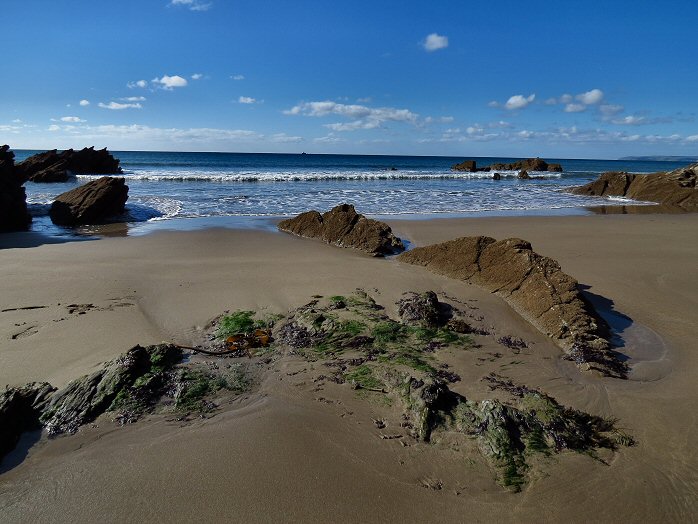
[398,236,627,377]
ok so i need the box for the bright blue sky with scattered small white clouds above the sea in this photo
[0,0,698,158]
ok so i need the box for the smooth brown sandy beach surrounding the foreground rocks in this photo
[0,215,698,522]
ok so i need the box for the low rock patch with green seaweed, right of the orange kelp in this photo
[275,290,633,491]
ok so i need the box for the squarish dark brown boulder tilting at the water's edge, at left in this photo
[50,177,128,226]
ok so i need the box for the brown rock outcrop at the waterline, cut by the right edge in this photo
[572,163,698,211]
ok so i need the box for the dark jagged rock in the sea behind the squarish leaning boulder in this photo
[16,147,122,182]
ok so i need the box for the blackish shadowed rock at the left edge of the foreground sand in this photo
[0,382,55,460]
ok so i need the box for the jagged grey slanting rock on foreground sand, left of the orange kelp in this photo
[41,344,182,435]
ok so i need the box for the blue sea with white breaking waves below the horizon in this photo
[15,150,685,234]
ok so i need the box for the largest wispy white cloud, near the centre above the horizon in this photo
[284,100,419,131]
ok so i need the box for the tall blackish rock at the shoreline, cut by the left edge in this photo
[0,145,31,232]
